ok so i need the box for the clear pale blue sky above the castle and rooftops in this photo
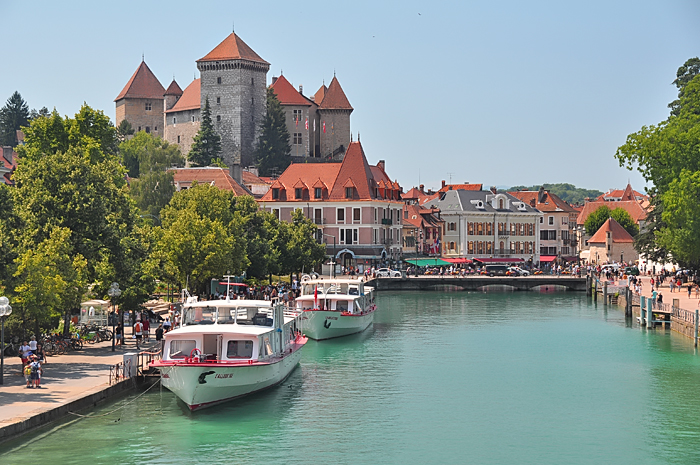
[0,0,700,190]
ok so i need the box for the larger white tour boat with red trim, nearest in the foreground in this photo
[152,298,307,411]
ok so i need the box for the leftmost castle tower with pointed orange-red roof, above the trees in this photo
[114,61,165,137]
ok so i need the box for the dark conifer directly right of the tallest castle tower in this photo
[255,87,292,176]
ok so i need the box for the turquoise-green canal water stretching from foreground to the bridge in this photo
[0,292,700,465]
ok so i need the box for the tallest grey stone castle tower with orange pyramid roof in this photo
[197,33,270,166]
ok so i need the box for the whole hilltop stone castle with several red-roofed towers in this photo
[114,33,353,172]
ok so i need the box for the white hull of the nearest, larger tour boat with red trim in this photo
[154,344,303,411]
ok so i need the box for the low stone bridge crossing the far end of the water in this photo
[368,275,586,291]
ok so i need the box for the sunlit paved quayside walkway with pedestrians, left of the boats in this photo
[0,330,154,428]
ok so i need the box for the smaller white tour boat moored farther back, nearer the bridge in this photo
[296,277,377,340]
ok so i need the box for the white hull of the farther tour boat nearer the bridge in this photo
[302,307,376,341]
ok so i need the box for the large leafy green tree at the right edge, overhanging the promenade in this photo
[615,59,700,269]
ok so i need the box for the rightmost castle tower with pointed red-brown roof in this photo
[314,76,353,158]
